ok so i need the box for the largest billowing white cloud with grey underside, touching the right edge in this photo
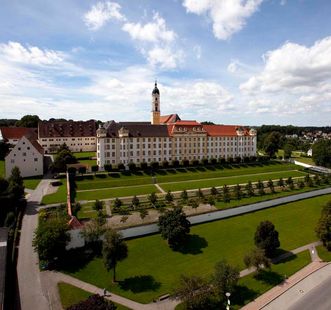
[240,37,331,115]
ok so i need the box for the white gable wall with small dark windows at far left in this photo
[5,137,44,178]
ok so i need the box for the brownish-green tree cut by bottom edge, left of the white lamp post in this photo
[174,275,212,310]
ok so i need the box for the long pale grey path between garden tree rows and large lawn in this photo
[121,187,331,238]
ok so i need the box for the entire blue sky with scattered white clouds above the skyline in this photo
[0,0,331,125]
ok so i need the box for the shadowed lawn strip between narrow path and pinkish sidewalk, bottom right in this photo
[231,251,311,309]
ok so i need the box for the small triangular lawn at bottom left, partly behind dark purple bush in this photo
[58,282,129,310]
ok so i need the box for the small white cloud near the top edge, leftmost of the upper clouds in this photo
[84,1,126,30]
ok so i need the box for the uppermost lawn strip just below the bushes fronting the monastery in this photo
[76,163,300,190]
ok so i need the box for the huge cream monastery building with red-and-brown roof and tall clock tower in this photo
[97,83,256,170]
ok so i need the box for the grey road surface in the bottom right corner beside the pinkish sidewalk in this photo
[262,264,331,310]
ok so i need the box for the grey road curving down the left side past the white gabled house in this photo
[17,179,50,310]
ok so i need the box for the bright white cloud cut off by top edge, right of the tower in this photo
[183,0,263,40]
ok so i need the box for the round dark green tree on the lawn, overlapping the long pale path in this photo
[158,207,191,248]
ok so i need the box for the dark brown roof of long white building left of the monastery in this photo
[38,120,96,138]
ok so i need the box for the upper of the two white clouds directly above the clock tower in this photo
[122,13,176,43]
